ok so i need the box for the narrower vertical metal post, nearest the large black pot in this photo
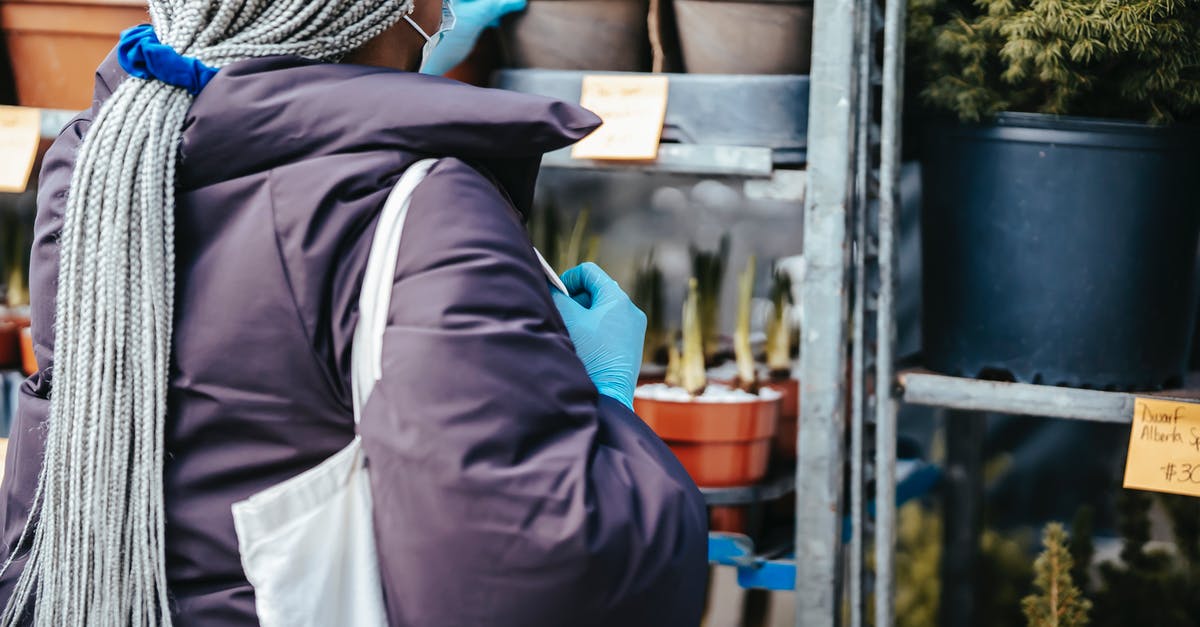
[875,0,907,627]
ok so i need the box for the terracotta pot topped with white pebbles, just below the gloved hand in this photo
[634,386,779,488]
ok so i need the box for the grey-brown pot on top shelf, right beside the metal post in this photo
[674,0,812,74]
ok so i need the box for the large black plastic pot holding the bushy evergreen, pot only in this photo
[922,114,1200,389]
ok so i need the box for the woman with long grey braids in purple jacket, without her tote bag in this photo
[0,0,706,627]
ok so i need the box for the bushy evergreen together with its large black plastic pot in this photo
[908,0,1200,389]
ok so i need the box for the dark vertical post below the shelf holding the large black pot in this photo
[942,411,985,627]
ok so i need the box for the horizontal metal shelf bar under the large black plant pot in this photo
[898,370,1200,423]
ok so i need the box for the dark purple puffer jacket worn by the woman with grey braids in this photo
[0,58,707,627]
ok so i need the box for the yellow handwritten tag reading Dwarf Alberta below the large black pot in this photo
[1124,399,1200,496]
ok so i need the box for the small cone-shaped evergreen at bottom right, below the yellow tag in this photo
[1021,523,1092,627]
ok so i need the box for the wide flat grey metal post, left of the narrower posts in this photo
[796,0,863,614]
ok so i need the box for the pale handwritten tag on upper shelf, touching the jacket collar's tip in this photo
[571,74,667,161]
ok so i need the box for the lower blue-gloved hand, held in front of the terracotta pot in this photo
[553,263,646,410]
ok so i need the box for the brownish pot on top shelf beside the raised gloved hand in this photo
[500,0,650,72]
